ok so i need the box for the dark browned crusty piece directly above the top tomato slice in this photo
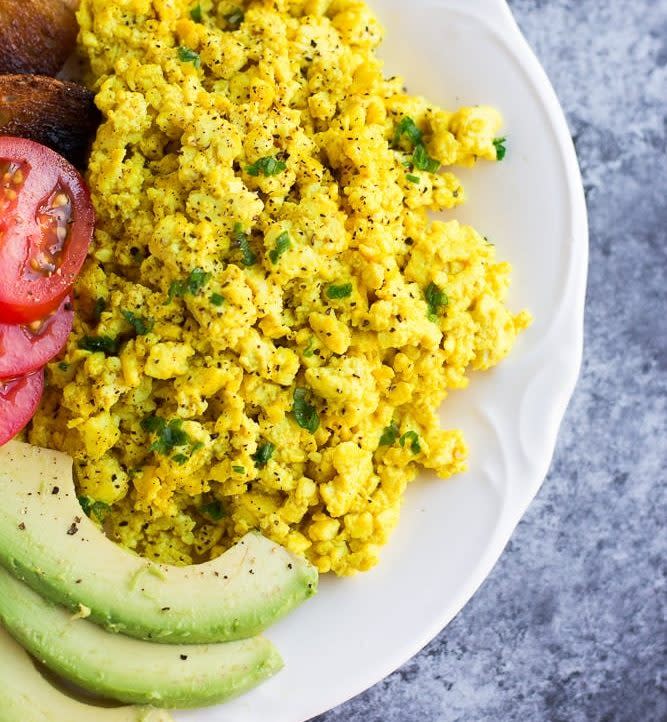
[0,75,101,168]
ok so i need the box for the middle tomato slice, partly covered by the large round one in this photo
[0,296,74,379]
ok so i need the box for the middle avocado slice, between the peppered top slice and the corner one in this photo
[0,568,282,704]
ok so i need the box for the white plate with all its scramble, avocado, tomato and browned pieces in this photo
[0,0,587,722]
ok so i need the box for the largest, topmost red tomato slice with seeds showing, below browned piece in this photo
[0,136,95,323]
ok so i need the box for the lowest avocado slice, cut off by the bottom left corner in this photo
[0,627,173,722]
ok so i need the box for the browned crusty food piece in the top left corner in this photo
[0,0,78,75]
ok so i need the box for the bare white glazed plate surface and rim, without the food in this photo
[176,0,588,722]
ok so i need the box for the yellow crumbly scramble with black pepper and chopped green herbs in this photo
[30,0,529,575]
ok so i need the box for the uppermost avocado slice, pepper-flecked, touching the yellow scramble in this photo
[0,442,317,644]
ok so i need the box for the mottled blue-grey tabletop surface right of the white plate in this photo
[314,0,667,722]
